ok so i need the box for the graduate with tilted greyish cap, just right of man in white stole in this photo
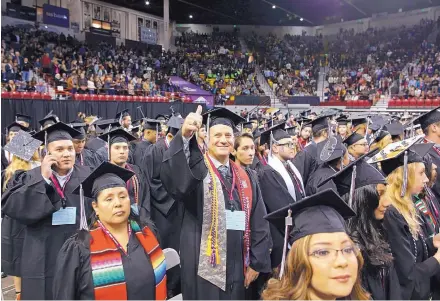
[306,136,349,195]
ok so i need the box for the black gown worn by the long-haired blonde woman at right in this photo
[383,206,440,300]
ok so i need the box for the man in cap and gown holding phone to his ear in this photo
[2,122,91,300]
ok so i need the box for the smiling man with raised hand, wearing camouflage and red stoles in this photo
[160,106,270,299]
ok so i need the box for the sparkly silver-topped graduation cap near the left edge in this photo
[4,130,42,161]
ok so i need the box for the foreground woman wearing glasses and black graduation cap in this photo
[262,189,370,300]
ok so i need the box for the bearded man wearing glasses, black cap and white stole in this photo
[259,122,305,268]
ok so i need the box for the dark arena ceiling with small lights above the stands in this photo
[105,0,440,26]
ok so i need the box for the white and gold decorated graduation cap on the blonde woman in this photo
[368,135,426,197]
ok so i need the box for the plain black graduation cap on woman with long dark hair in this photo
[318,151,386,208]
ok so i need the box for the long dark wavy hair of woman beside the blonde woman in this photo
[342,184,393,274]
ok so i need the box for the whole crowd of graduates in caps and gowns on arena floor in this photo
[1,107,440,300]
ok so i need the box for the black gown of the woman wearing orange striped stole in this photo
[53,233,156,300]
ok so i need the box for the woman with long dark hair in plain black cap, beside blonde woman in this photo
[320,154,402,300]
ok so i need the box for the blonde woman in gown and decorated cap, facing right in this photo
[369,140,440,300]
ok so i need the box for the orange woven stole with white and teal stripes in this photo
[90,221,167,300]
